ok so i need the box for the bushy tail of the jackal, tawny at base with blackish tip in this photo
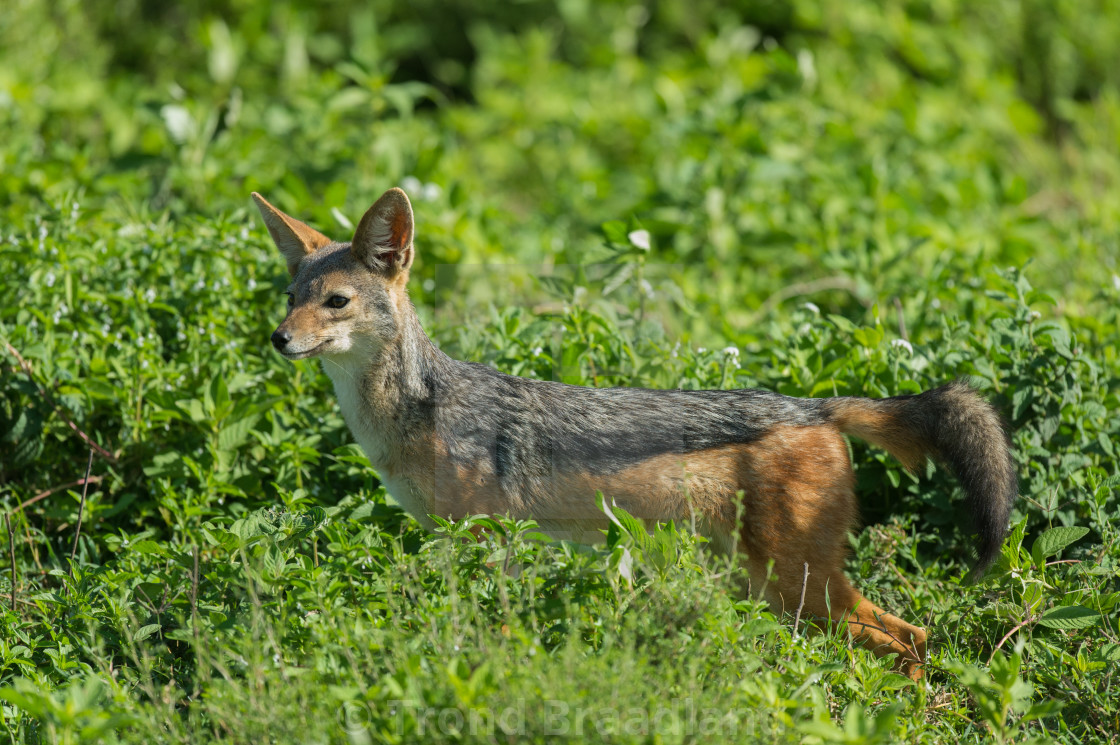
[829,381,1019,571]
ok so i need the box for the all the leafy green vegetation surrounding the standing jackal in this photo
[0,0,1120,743]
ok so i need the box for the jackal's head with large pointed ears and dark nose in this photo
[253,188,413,361]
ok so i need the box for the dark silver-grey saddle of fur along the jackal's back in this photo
[439,364,828,475]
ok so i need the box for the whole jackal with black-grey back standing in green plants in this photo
[253,188,1018,678]
